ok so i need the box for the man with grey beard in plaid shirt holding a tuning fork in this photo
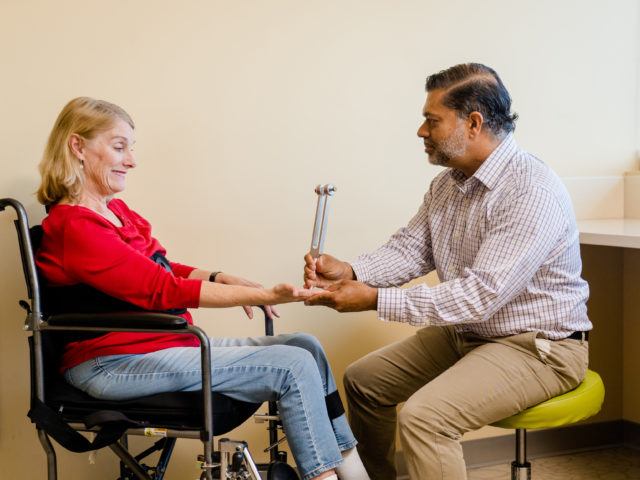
[305,64,592,480]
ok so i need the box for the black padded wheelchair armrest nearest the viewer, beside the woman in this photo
[47,312,189,330]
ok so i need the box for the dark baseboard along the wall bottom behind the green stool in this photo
[396,420,640,480]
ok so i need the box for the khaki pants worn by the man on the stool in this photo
[345,327,588,480]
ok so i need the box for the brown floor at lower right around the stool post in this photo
[468,447,640,480]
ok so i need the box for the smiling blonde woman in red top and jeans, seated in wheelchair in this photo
[36,97,368,479]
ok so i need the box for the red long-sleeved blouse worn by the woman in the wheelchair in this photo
[36,199,202,371]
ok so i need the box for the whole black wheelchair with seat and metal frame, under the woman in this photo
[0,198,299,480]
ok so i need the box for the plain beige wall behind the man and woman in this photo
[0,0,639,479]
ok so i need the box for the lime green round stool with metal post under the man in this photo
[492,370,604,480]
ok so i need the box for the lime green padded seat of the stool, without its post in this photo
[492,370,604,429]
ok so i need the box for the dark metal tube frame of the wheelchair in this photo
[0,198,298,480]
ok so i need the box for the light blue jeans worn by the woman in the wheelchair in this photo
[65,333,356,480]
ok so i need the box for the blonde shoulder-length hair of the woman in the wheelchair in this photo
[37,97,135,205]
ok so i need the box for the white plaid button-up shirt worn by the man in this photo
[352,135,592,340]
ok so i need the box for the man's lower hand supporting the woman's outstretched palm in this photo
[304,280,378,312]
